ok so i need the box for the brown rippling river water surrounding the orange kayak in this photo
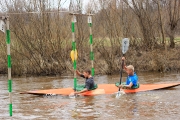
[0,73,180,120]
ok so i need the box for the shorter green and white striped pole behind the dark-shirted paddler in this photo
[88,15,95,76]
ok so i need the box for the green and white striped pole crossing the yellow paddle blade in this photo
[71,15,77,89]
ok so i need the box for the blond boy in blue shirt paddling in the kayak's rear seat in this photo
[118,57,139,89]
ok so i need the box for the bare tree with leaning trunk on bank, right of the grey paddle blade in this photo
[124,0,157,49]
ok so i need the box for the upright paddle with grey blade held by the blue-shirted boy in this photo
[116,38,129,98]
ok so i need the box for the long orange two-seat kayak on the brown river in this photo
[21,82,180,96]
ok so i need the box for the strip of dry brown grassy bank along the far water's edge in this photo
[0,47,180,76]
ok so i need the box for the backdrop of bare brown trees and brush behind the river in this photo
[0,0,180,75]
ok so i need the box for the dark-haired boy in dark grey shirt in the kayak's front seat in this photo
[74,69,95,94]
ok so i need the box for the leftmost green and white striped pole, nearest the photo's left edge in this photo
[5,17,12,116]
